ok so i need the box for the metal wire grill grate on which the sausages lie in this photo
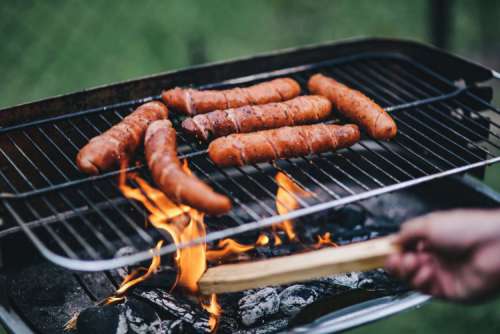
[0,54,500,270]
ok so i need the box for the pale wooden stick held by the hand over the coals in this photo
[198,237,398,295]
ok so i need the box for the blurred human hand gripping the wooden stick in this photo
[386,209,500,302]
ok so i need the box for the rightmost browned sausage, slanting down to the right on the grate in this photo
[307,74,398,140]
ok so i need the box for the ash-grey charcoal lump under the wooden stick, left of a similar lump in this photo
[238,287,279,326]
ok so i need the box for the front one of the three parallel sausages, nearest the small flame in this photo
[208,124,360,167]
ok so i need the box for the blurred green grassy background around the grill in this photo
[0,0,500,333]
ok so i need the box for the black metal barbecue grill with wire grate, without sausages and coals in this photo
[0,39,500,332]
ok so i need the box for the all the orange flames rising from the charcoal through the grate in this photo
[112,160,333,331]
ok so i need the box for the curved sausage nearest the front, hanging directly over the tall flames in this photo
[144,120,231,215]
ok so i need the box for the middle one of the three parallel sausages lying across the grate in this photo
[182,95,332,140]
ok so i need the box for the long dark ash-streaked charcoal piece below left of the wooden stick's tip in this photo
[133,289,210,333]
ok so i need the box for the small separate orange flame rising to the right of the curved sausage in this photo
[273,172,311,241]
